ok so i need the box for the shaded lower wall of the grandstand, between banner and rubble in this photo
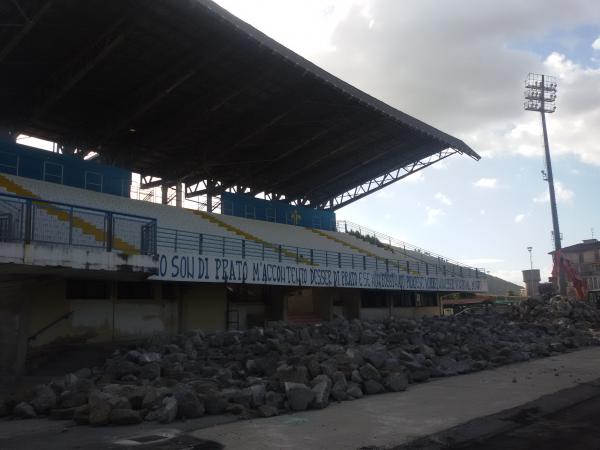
[0,271,448,379]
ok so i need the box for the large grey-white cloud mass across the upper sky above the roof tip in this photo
[217,0,600,167]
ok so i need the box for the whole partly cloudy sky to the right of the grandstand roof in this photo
[212,0,600,284]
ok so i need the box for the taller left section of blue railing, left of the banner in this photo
[0,194,156,255]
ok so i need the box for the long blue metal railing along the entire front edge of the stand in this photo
[0,194,485,278]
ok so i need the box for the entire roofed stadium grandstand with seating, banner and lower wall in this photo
[0,0,487,375]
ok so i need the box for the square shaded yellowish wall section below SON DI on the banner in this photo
[181,284,227,332]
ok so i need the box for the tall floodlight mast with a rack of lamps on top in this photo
[524,73,567,295]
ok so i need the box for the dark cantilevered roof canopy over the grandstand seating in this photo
[0,0,479,209]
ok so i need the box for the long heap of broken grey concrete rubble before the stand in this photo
[0,299,600,425]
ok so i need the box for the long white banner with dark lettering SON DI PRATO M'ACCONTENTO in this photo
[150,253,487,292]
